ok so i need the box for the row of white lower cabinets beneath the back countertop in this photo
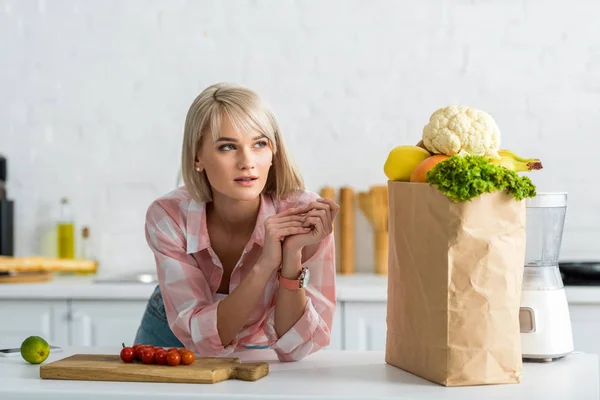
[0,299,600,354]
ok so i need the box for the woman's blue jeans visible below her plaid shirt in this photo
[133,285,269,349]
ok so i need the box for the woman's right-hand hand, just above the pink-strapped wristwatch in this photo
[283,199,340,252]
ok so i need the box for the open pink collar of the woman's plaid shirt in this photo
[186,194,277,254]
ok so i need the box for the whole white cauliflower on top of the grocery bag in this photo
[423,106,500,158]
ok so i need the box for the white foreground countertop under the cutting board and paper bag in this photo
[0,347,600,400]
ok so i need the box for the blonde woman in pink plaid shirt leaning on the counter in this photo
[135,83,339,361]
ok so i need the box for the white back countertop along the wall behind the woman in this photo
[0,273,600,304]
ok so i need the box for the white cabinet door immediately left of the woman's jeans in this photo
[69,300,147,346]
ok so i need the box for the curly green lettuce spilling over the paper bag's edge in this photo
[426,155,536,203]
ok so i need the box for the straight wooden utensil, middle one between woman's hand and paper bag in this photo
[340,187,356,274]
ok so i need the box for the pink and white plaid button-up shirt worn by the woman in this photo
[146,187,336,361]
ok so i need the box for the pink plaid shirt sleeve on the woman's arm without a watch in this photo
[146,202,237,357]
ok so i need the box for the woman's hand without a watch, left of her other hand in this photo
[257,208,311,272]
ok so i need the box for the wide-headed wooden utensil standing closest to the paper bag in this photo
[358,185,389,275]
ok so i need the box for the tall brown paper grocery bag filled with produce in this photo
[385,181,526,386]
